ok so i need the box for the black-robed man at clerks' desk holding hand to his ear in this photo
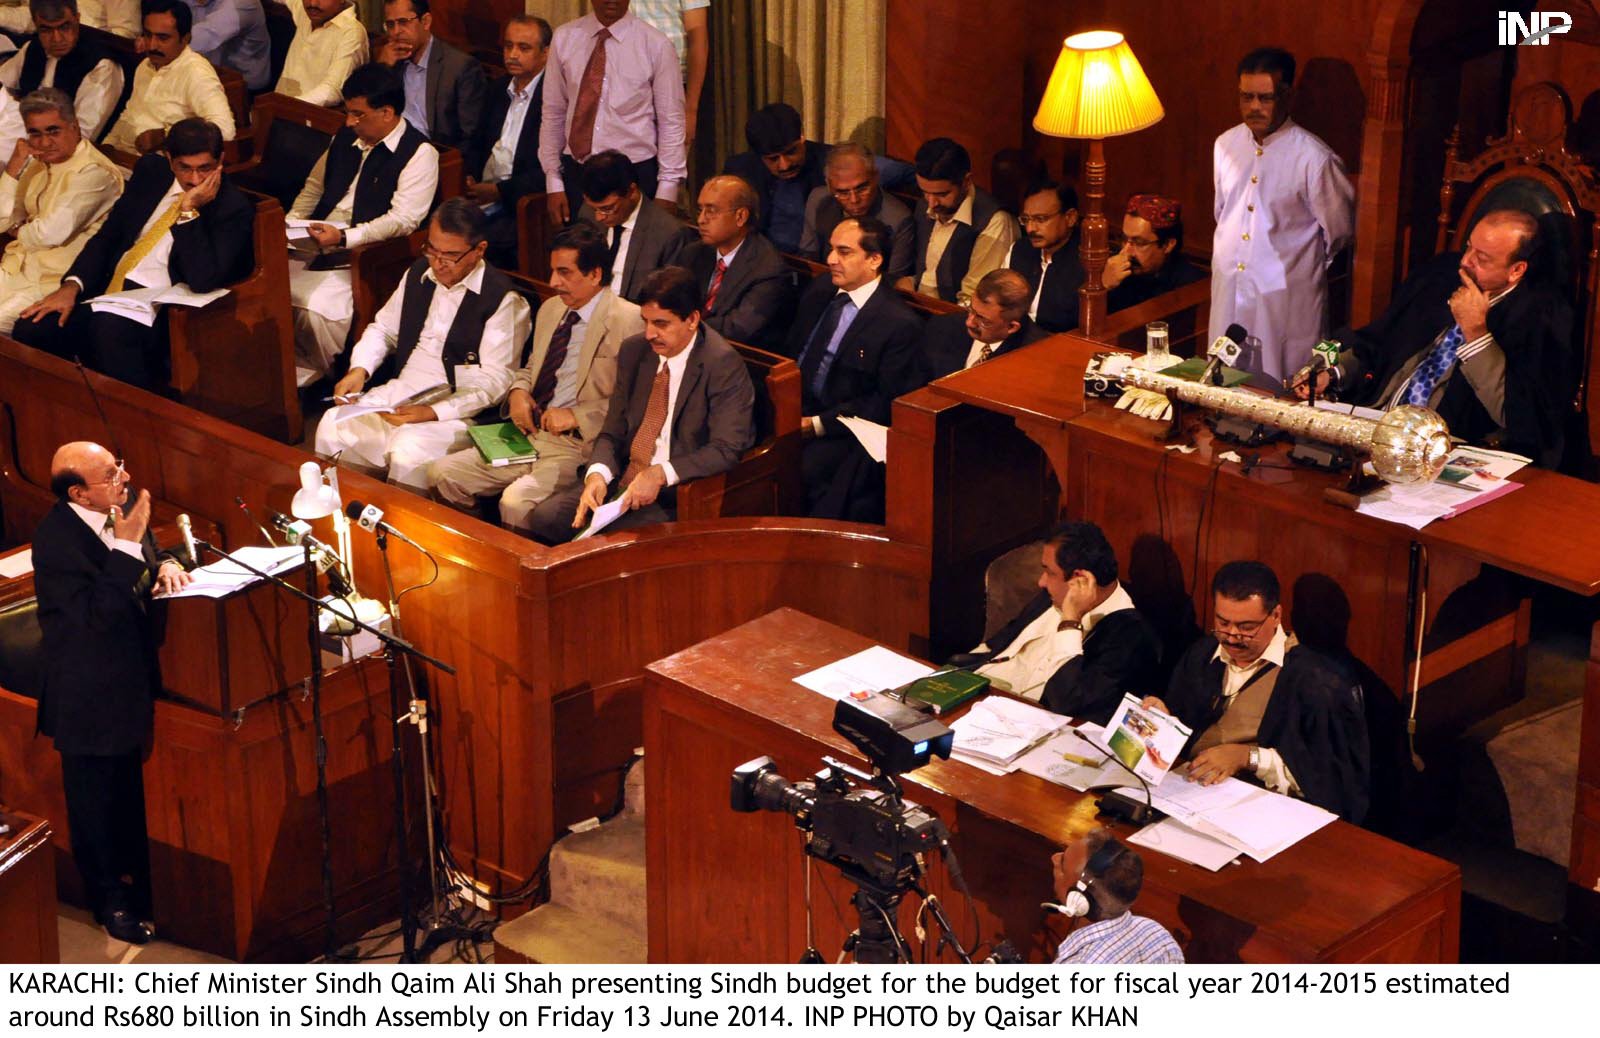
[950,523,1162,725]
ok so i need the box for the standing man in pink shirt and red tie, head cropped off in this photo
[539,0,688,226]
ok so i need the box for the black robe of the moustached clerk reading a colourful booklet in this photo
[1166,635,1371,822]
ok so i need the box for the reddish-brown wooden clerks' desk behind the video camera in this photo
[645,609,1461,963]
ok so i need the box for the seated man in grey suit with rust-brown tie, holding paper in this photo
[533,263,755,544]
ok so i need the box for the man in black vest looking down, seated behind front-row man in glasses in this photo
[288,64,438,385]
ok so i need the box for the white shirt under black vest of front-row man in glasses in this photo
[350,261,533,422]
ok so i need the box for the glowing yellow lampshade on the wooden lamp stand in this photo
[1034,30,1166,139]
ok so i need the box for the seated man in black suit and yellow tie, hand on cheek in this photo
[11,118,256,389]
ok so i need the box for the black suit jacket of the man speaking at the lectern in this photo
[34,488,162,757]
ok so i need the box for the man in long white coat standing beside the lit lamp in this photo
[1210,46,1355,381]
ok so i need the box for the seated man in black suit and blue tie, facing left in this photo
[784,216,928,523]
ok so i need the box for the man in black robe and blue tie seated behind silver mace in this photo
[1294,210,1578,467]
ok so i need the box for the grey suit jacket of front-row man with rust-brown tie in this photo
[589,325,755,483]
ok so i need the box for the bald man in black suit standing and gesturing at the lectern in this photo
[34,441,189,944]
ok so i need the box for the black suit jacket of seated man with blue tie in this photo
[784,273,928,437]
